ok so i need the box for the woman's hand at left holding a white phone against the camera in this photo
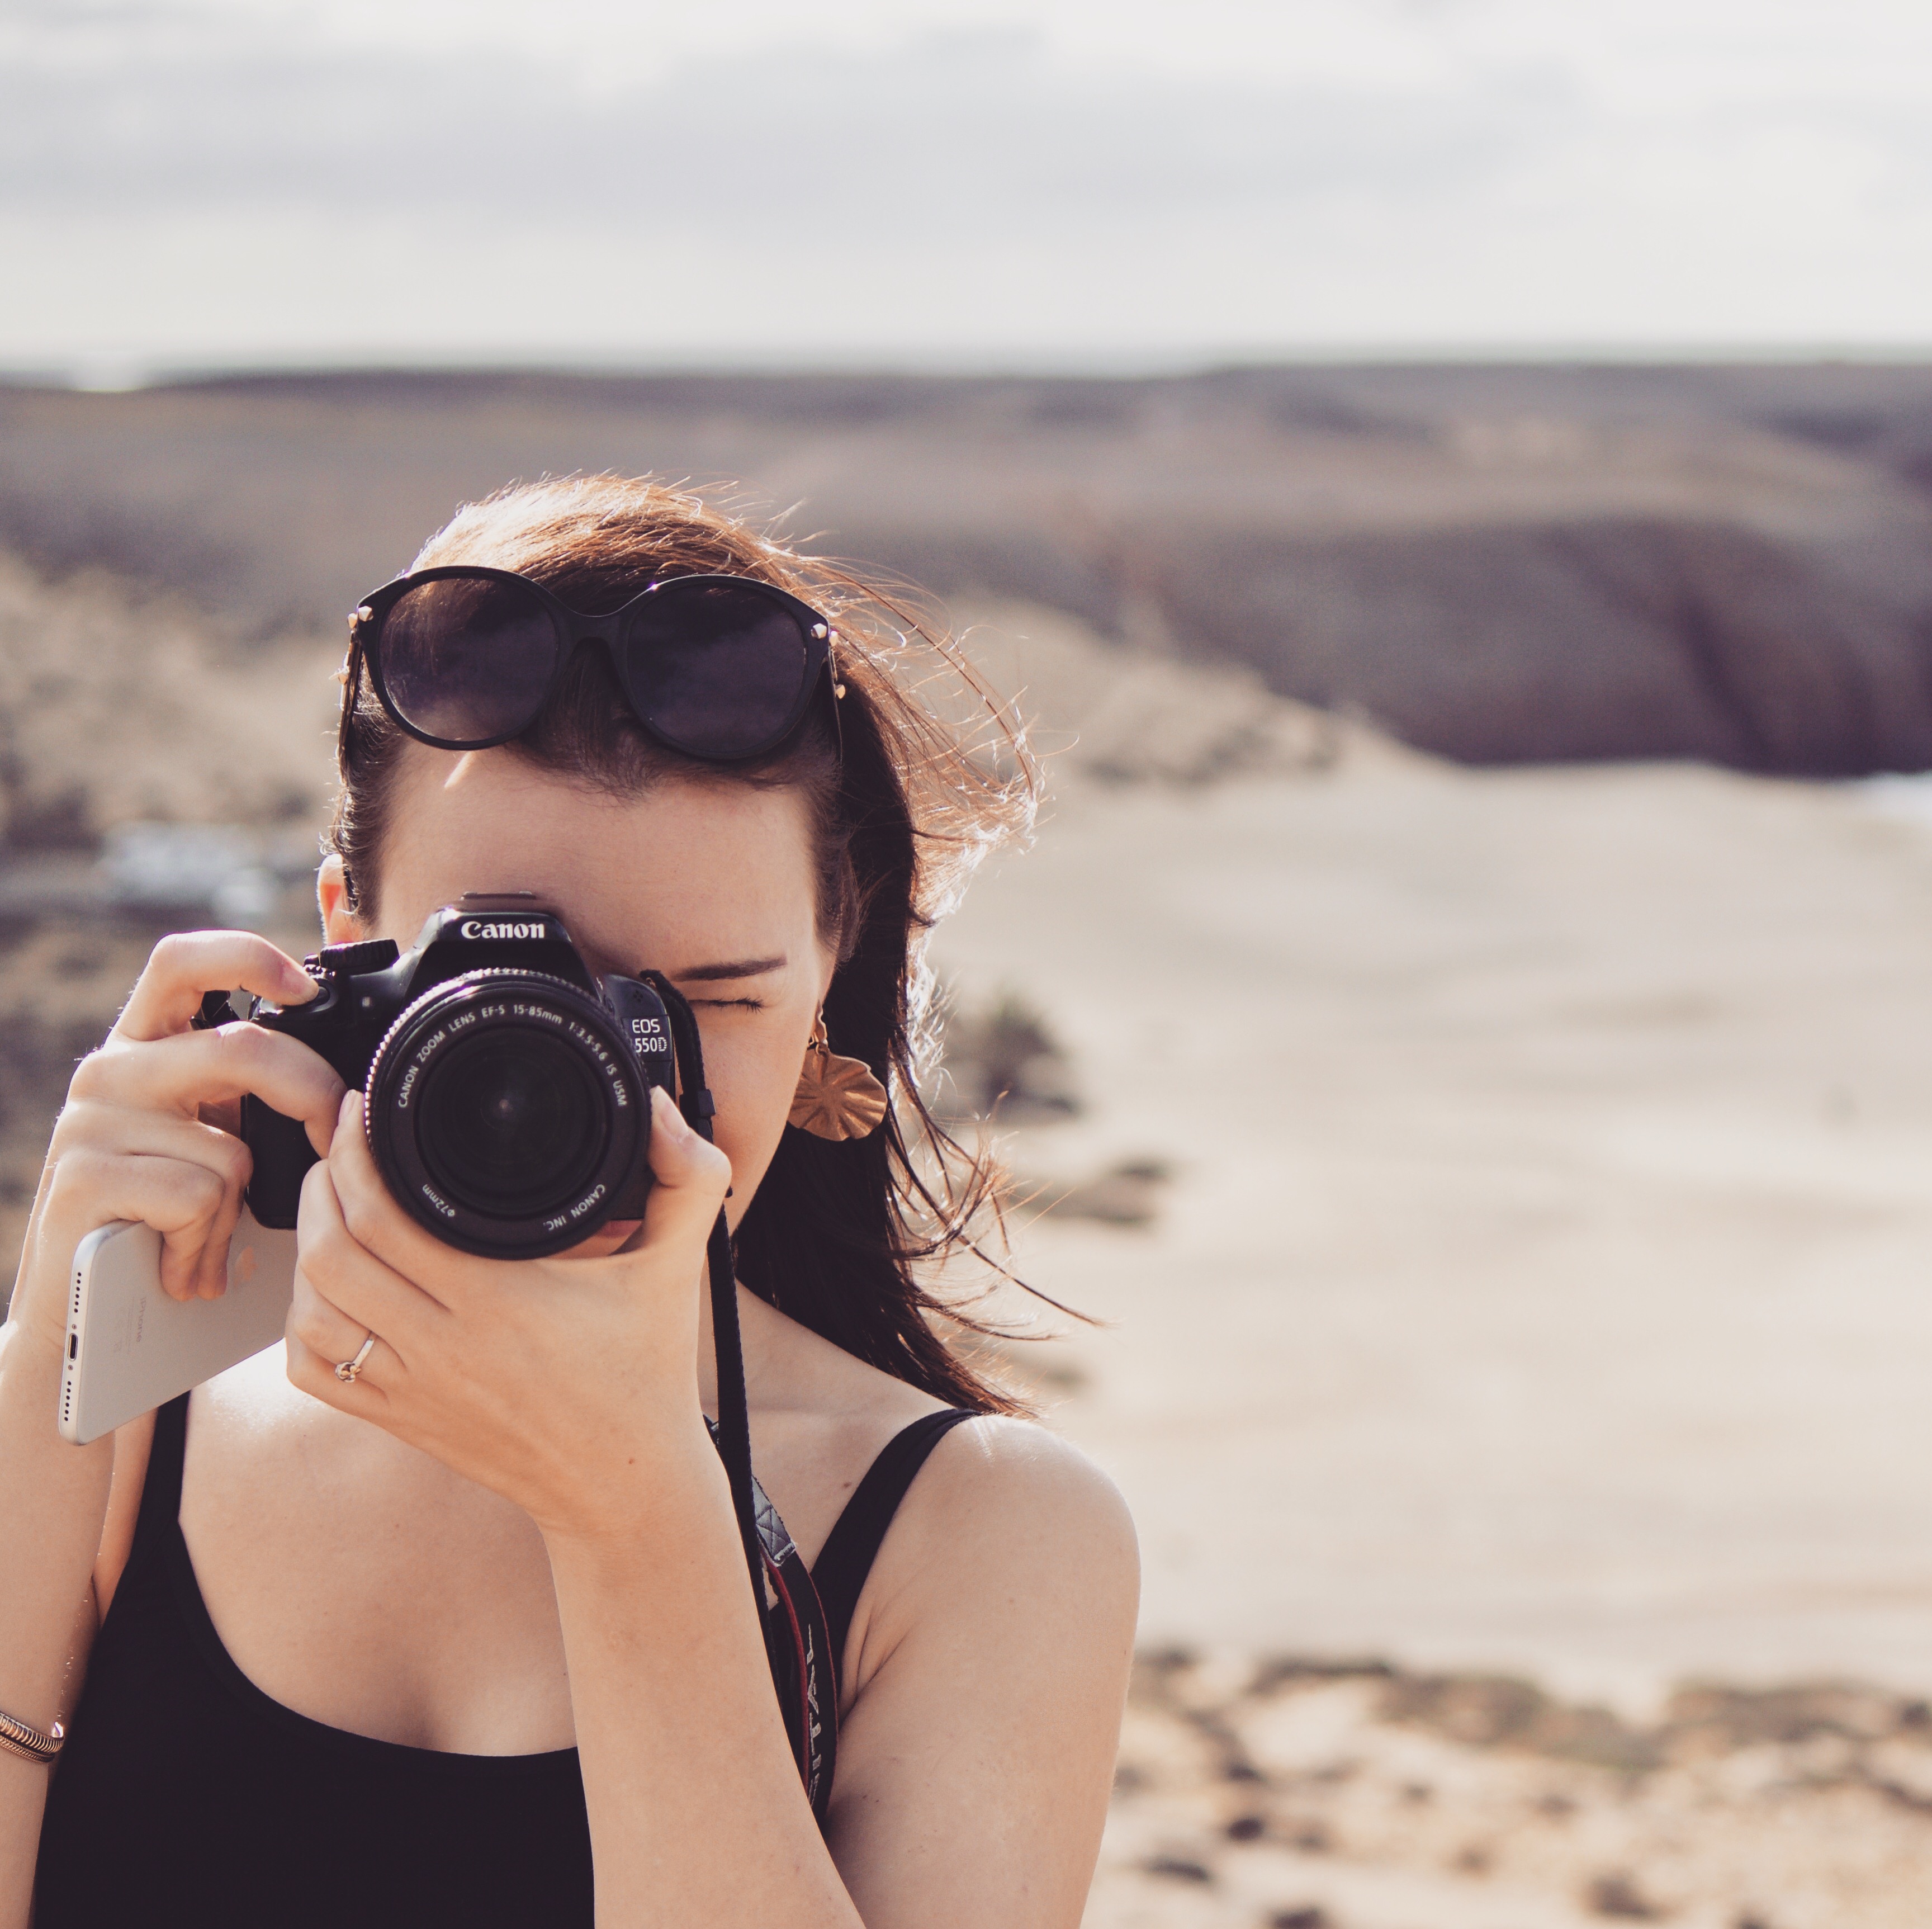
[12,932,344,1353]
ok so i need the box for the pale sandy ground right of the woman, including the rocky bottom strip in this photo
[920,715,1932,1929]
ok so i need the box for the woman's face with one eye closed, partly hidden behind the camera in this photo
[321,744,833,1252]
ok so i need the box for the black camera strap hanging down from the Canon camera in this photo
[640,970,839,1828]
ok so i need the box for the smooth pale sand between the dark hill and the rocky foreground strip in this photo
[939,748,1932,1709]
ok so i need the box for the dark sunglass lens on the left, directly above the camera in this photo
[378,576,556,744]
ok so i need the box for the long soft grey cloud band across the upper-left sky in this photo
[0,33,1569,232]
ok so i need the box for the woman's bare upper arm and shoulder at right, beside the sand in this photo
[831,1419,1140,1929]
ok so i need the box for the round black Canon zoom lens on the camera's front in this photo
[363,970,651,1258]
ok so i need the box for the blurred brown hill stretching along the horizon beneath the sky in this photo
[0,365,1932,775]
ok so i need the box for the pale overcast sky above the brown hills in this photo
[0,0,1932,379]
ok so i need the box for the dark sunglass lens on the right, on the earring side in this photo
[624,584,812,758]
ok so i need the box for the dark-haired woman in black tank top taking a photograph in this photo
[0,479,1136,1929]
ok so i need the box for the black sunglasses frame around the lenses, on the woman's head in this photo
[342,562,844,763]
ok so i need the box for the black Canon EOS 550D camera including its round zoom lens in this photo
[242,893,676,1258]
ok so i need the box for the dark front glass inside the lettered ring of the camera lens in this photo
[414,1024,610,1219]
